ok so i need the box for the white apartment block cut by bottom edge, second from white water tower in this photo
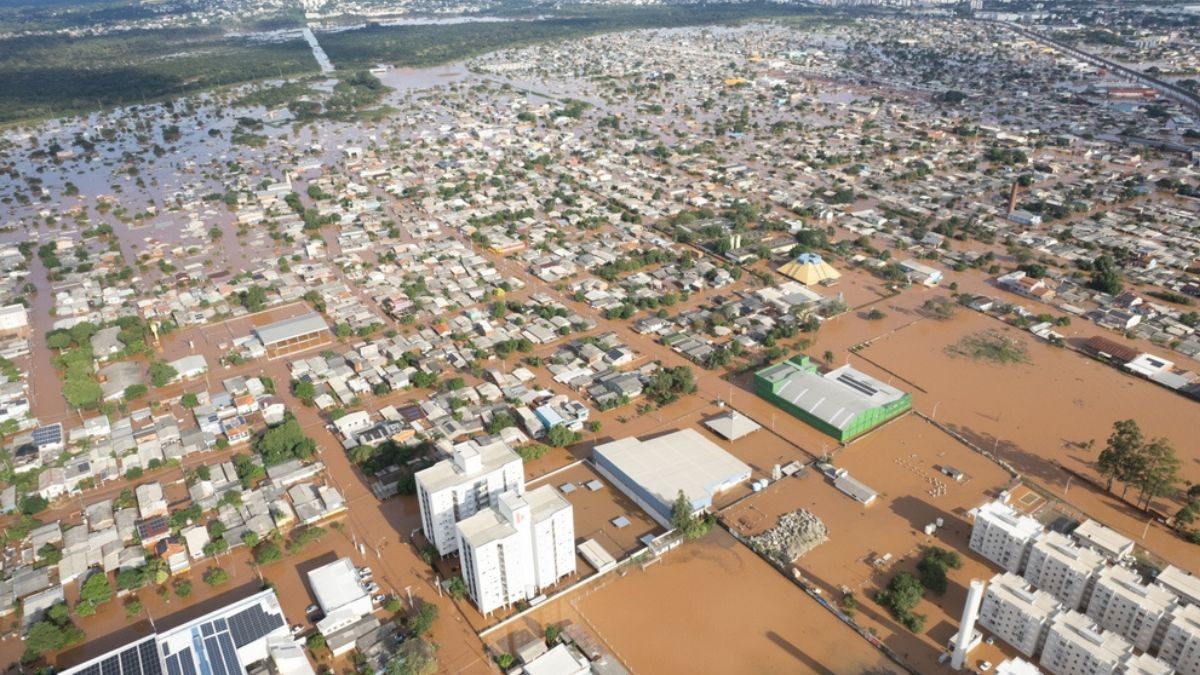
[1038,611,1133,675]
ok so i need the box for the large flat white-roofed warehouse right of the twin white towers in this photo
[592,429,750,527]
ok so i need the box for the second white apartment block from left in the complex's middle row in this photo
[1024,530,1104,609]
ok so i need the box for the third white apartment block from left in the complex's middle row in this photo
[1087,566,1178,651]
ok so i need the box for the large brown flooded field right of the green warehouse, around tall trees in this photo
[851,310,1200,571]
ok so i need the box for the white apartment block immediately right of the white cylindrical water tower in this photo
[979,572,1058,657]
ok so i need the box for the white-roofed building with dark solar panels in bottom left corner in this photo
[62,590,313,675]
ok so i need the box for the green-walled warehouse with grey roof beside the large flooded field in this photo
[754,354,912,443]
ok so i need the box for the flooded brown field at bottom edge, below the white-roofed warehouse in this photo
[487,528,900,674]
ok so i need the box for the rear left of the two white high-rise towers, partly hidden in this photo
[415,441,524,555]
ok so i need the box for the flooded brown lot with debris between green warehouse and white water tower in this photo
[721,414,1010,671]
